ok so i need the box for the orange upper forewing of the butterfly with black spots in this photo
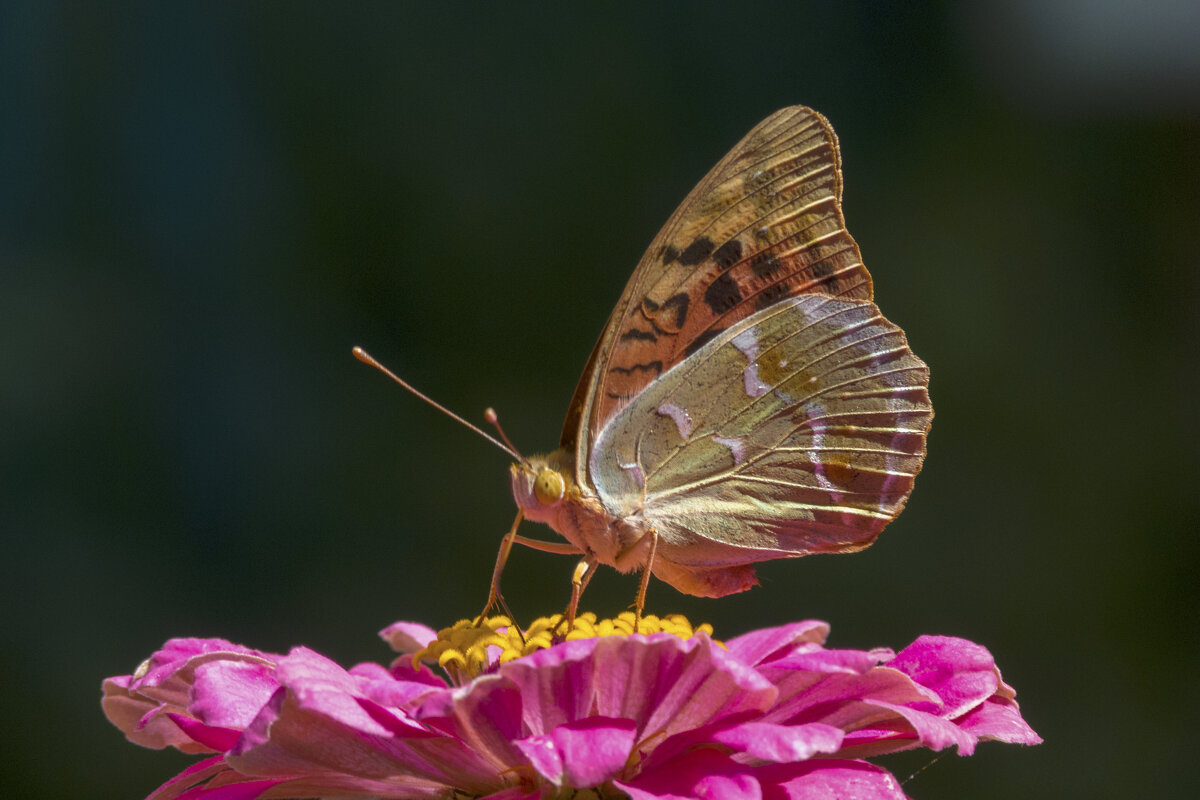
[563,107,871,477]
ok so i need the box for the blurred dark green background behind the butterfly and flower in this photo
[0,0,1200,800]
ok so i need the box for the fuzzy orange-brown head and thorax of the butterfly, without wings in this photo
[511,449,646,572]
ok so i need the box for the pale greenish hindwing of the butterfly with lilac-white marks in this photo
[589,295,932,566]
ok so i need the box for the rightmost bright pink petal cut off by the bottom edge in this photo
[755,759,907,800]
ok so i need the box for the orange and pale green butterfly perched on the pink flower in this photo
[360,106,934,619]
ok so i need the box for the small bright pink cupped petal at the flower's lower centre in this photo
[516,717,637,789]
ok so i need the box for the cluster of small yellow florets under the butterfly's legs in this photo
[413,612,713,682]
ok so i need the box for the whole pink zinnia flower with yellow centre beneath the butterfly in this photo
[103,616,1040,800]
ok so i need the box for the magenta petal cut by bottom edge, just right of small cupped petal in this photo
[613,748,762,800]
